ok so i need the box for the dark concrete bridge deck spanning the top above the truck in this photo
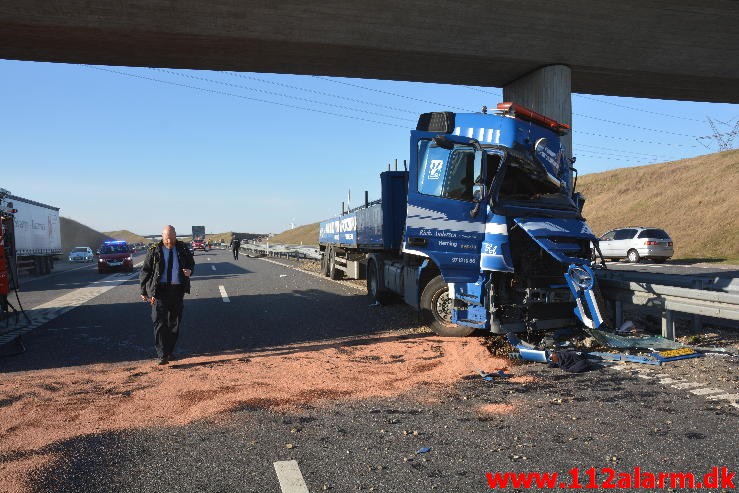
[0,0,739,152]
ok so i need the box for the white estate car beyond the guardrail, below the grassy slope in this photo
[599,226,675,264]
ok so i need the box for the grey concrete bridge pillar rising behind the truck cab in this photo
[503,65,572,157]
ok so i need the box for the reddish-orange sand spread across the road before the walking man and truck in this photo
[0,333,528,492]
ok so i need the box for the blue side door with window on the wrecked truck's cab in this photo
[403,140,486,282]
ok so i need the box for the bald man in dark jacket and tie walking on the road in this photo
[139,225,195,365]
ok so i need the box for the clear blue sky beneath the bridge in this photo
[0,60,739,234]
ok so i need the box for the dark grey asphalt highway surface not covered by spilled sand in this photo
[0,250,739,493]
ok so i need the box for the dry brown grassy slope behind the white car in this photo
[578,150,739,260]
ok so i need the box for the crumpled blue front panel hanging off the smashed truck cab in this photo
[514,218,603,329]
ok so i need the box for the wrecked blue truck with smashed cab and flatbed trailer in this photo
[319,103,604,336]
